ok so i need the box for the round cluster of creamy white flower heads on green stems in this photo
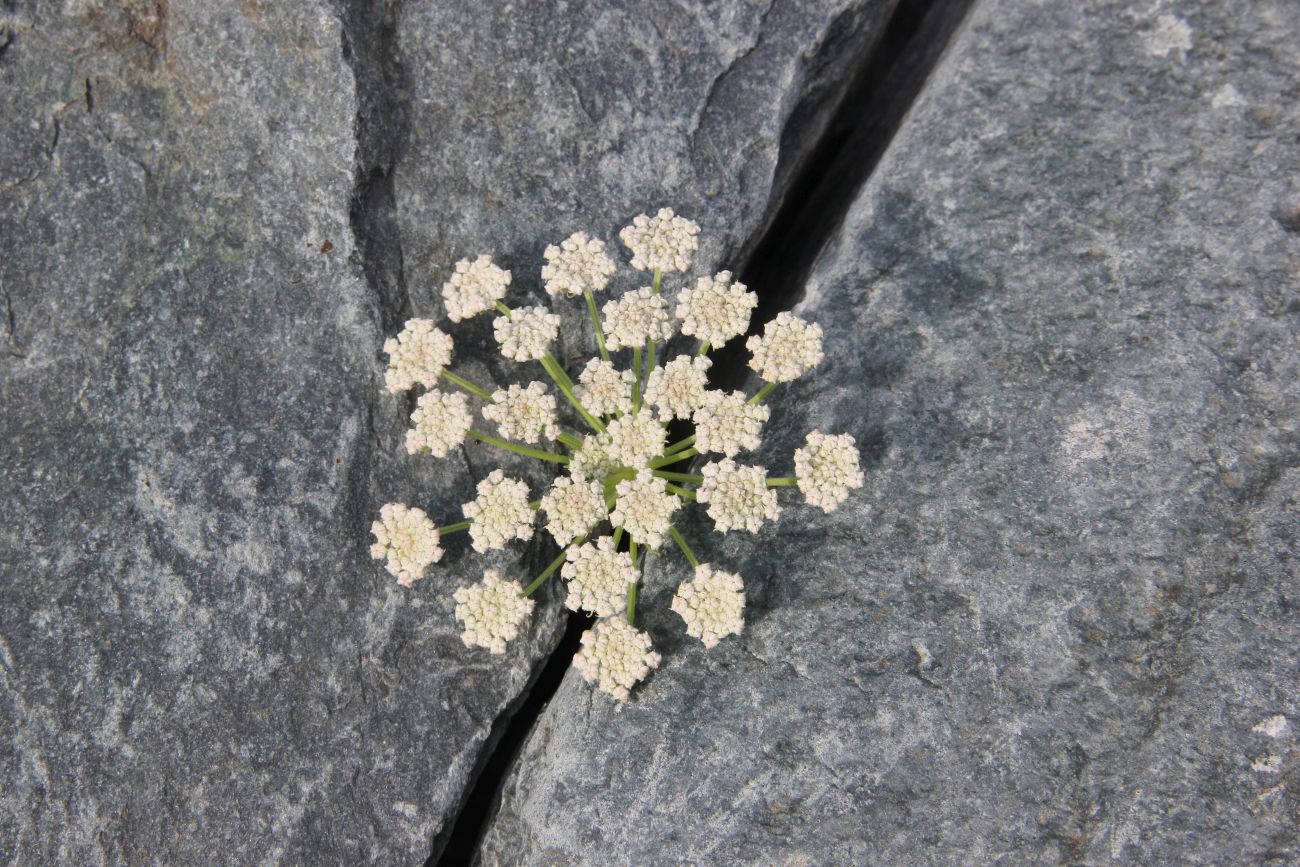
[371,208,862,701]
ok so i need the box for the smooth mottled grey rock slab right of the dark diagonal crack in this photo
[484,0,1300,864]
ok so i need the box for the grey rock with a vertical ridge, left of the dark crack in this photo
[0,0,893,864]
